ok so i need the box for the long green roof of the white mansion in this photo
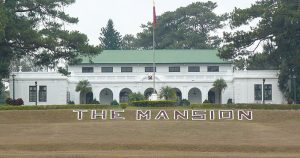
[82,49,231,64]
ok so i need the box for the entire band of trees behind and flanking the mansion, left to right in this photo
[0,0,300,101]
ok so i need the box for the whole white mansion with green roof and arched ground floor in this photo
[9,50,286,105]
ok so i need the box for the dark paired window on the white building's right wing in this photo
[254,84,272,100]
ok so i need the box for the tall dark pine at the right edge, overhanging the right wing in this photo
[219,0,300,96]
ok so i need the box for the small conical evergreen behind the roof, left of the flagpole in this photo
[99,19,121,50]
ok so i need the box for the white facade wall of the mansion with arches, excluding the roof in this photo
[10,67,285,105]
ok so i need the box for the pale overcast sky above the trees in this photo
[65,0,256,45]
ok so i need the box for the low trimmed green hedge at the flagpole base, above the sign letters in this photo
[131,100,176,107]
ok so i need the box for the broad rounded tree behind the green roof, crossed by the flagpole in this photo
[136,1,227,49]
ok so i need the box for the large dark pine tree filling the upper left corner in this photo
[0,0,101,78]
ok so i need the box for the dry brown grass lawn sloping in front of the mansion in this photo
[0,108,300,158]
